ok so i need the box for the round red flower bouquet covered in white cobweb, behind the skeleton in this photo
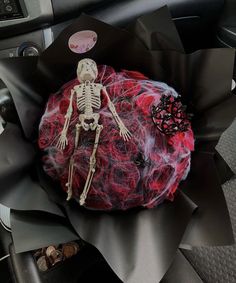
[38,66,194,210]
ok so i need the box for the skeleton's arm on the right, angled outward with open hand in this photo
[102,87,132,141]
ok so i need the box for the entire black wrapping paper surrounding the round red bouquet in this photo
[0,8,236,283]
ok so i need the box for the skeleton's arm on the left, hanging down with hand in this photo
[56,89,75,150]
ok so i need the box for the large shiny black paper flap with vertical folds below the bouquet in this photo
[67,194,196,282]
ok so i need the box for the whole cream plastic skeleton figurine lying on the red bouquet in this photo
[56,59,132,205]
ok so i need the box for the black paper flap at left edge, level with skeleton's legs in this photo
[0,123,64,217]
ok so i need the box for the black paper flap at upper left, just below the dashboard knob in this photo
[0,57,44,138]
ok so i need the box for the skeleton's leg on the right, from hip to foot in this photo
[80,125,103,205]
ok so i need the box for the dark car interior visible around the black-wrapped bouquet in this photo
[0,0,236,283]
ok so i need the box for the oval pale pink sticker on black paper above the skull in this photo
[68,30,98,54]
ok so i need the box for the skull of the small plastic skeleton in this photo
[77,58,98,83]
